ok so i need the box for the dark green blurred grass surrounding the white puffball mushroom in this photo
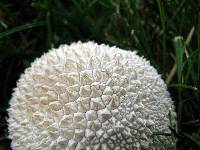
[0,0,200,150]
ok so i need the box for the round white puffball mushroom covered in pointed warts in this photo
[8,42,175,150]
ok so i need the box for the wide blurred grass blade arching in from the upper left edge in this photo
[0,21,45,39]
